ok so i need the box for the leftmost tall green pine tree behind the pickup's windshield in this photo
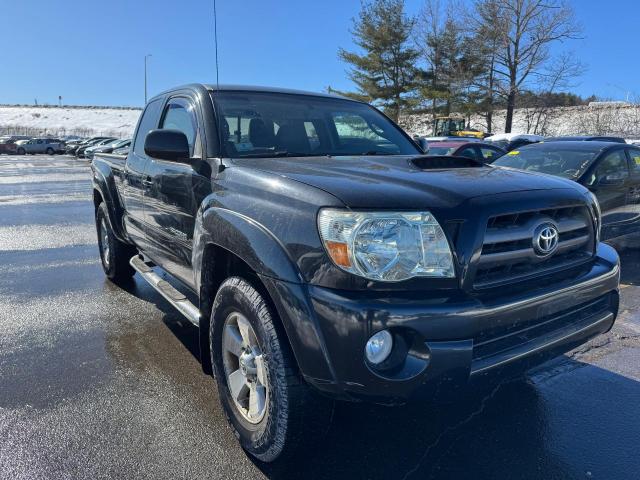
[339,0,419,121]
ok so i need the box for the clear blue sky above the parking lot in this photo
[0,0,640,106]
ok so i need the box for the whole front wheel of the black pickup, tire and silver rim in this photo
[209,277,332,462]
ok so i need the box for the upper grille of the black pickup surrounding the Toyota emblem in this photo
[473,206,595,289]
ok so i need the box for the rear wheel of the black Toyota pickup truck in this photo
[96,202,137,283]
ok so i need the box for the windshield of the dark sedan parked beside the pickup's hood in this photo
[493,143,599,179]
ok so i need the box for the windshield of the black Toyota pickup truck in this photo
[212,92,420,158]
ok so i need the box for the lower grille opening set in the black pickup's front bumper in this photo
[473,294,611,361]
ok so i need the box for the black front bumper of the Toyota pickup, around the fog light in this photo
[265,244,620,403]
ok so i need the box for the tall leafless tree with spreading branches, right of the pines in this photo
[476,0,581,133]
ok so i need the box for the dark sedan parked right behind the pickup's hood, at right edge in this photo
[494,141,640,240]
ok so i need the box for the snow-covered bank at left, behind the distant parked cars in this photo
[0,105,141,137]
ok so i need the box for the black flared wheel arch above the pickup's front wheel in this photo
[193,207,303,291]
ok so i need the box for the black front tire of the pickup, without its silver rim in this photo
[209,277,333,462]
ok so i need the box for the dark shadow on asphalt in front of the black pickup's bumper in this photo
[257,358,640,479]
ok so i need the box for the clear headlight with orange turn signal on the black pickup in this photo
[318,209,455,282]
